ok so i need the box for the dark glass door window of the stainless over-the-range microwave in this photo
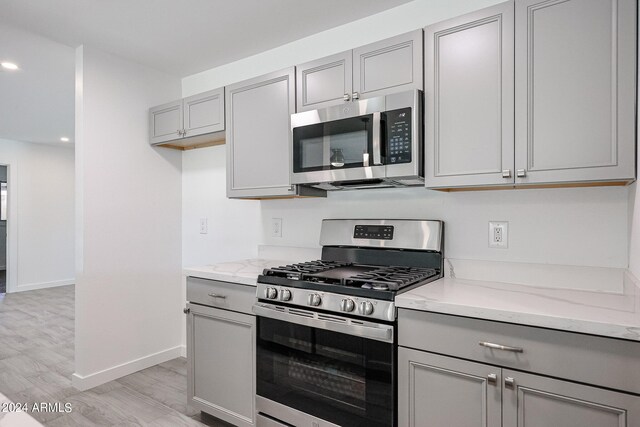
[293,115,373,172]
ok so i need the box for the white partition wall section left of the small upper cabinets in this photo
[73,46,184,389]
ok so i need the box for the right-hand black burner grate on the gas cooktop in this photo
[345,267,438,291]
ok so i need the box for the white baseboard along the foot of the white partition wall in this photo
[71,345,183,391]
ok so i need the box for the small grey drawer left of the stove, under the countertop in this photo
[187,277,256,314]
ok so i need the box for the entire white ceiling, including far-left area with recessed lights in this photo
[0,0,410,144]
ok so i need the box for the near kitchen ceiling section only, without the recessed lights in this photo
[0,0,409,77]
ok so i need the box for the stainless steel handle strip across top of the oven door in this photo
[253,303,393,343]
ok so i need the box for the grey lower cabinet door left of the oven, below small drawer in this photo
[187,304,256,426]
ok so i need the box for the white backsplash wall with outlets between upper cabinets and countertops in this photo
[183,146,629,267]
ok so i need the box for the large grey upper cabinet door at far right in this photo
[515,0,636,184]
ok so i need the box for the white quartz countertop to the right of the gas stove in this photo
[396,272,640,341]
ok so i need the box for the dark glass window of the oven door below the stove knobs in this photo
[257,317,395,427]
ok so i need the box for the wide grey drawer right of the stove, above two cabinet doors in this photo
[398,309,640,393]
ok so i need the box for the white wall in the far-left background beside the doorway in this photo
[0,139,75,292]
